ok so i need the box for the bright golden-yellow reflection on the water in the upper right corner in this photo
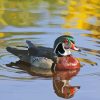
[62,0,100,31]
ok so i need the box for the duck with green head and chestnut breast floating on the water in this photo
[6,35,80,70]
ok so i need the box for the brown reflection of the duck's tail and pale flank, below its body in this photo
[6,61,52,78]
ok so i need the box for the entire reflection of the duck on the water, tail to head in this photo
[5,61,80,99]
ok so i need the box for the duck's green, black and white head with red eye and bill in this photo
[54,35,80,57]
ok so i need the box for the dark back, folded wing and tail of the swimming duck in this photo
[6,40,53,62]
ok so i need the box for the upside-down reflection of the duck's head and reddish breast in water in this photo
[53,69,80,99]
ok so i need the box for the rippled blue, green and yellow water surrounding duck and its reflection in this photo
[0,0,100,100]
